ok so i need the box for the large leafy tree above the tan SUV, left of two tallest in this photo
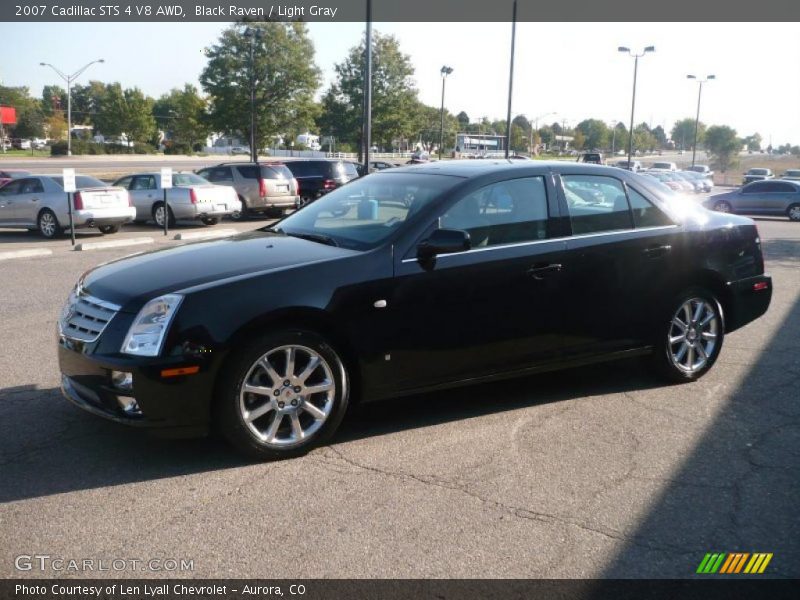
[200,22,320,148]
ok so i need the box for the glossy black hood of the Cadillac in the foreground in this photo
[80,231,356,312]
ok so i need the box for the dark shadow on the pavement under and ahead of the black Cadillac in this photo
[0,360,661,503]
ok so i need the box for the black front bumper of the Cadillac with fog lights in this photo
[58,336,214,437]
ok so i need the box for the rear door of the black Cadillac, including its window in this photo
[560,172,683,356]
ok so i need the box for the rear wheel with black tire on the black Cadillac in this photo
[652,287,725,383]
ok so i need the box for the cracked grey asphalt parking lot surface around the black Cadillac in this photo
[0,213,800,578]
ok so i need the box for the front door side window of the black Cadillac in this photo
[439,177,548,247]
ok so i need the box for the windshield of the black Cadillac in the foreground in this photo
[266,173,461,250]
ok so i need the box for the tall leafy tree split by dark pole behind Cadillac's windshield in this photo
[318,33,418,154]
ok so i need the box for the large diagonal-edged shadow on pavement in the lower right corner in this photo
[598,240,800,580]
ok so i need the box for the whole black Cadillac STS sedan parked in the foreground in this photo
[58,161,772,457]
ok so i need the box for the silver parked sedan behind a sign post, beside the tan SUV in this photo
[114,173,242,227]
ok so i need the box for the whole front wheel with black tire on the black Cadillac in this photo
[215,329,350,460]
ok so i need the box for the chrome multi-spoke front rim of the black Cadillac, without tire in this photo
[239,345,336,448]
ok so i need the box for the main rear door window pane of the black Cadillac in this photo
[562,175,632,235]
